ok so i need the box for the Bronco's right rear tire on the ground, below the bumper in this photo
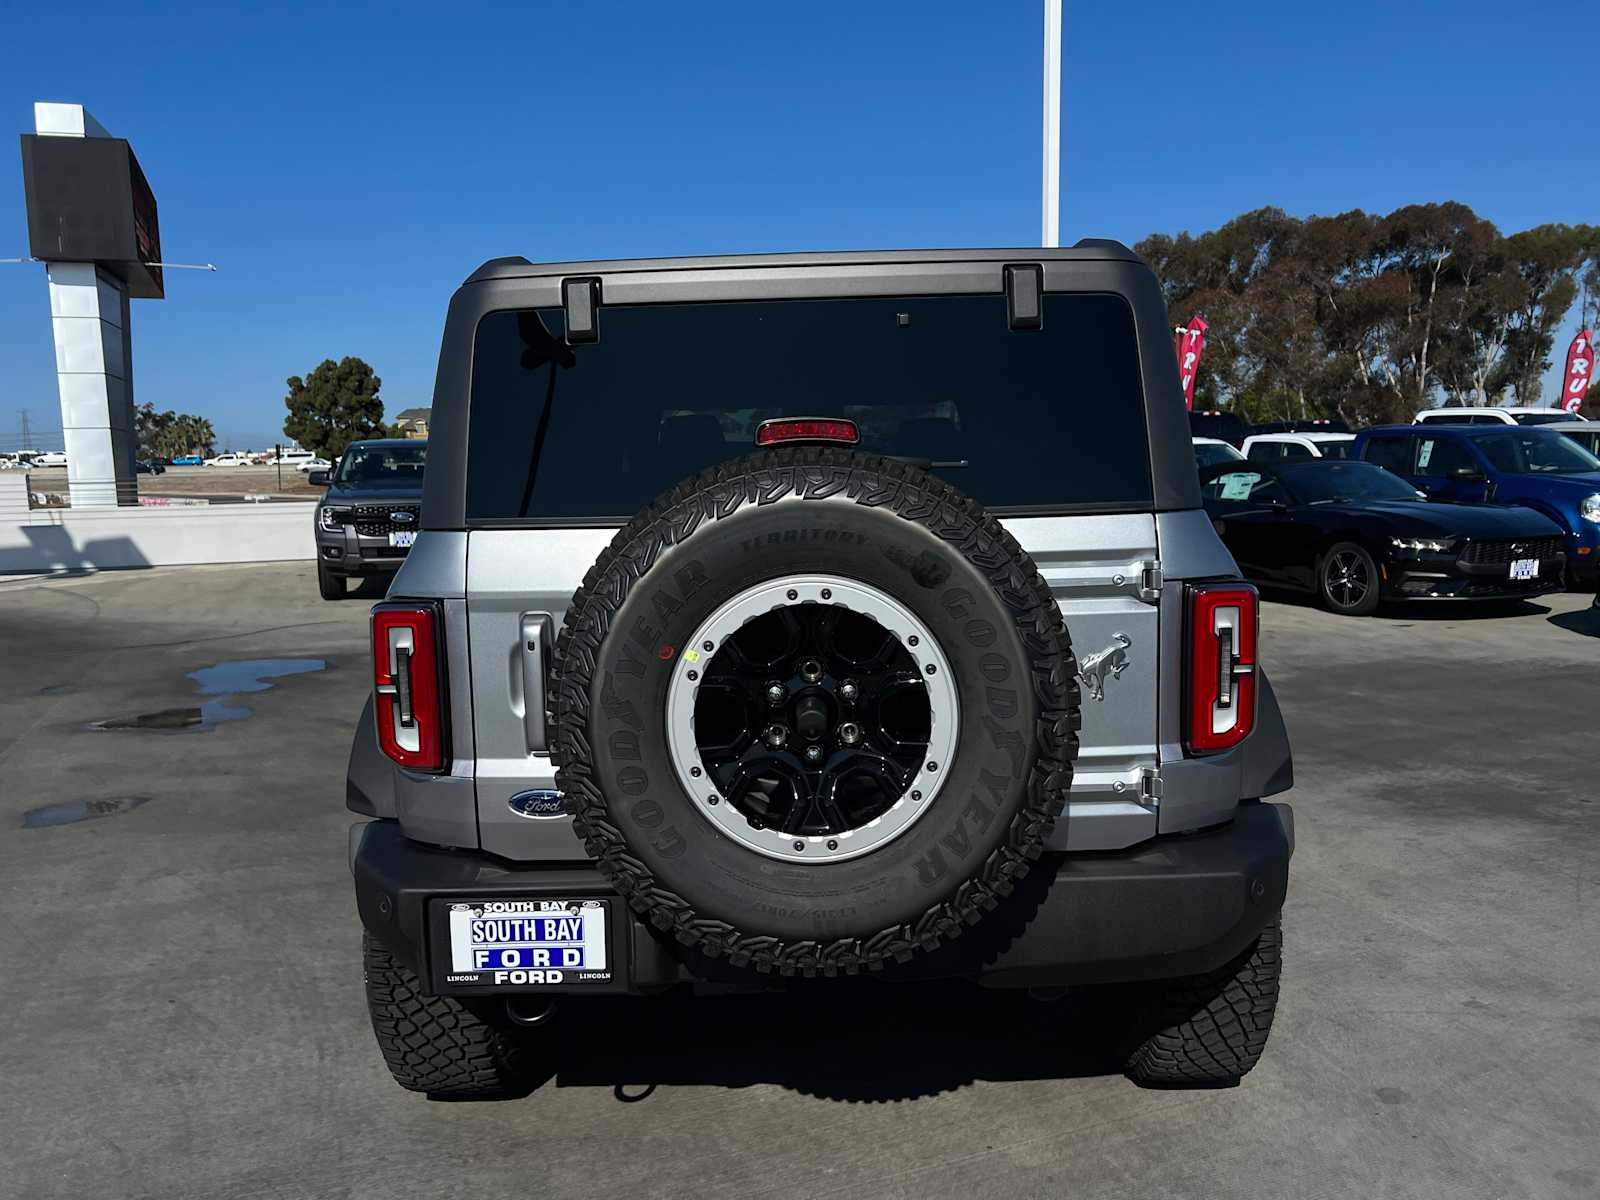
[1125,917,1283,1088]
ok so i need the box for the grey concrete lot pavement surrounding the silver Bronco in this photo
[0,563,1600,1200]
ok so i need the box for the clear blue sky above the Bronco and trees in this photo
[0,0,1600,446]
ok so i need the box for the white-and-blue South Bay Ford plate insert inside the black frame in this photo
[446,899,611,987]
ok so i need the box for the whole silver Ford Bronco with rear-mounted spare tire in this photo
[346,242,1294,1098]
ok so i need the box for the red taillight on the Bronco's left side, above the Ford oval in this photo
[373,603,446,771]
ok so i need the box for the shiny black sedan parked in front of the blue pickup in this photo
[1200,459,1566,616]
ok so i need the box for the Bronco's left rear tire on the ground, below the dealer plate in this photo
[362,933,541,1099]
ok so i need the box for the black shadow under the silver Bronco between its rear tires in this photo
[544,981,1120,1102]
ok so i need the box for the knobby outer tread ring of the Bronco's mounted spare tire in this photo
[547,446,1080,976]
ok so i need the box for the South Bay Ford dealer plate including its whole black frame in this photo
[434,896,619,992]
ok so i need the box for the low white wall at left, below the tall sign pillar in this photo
[0,472,317,574]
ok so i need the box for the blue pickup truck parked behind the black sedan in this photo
[1352,422,1600,586]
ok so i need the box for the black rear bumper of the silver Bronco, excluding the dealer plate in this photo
[350,802,1294,995]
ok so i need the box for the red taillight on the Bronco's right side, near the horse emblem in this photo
[1184,584,1259,754]
